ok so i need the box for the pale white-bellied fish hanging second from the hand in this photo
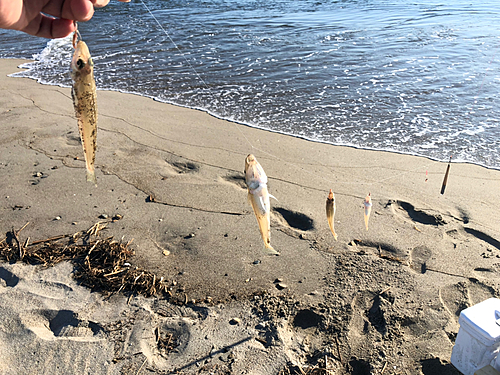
[245,154,279,255]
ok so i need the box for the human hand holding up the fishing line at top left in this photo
[0,0,130,38]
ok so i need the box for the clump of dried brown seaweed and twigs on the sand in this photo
[0,222,169,297]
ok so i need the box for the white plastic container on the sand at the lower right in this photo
[451,298,500,375]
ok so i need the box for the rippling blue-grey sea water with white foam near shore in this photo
[0,0,500,168]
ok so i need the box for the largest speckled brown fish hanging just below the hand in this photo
[71,31,97,185]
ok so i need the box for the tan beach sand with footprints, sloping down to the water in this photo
[0,60,500,375]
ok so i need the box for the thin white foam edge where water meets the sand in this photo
[5,58,500,170]
